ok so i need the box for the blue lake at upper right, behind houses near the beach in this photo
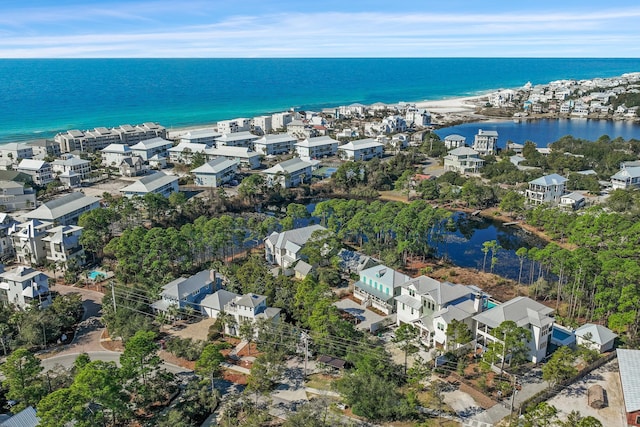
[435,118,640,148]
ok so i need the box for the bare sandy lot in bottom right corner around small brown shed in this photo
[549,360,626,426]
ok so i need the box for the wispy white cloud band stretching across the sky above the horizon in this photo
[0,8,640,57]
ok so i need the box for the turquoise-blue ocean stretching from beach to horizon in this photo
[0,58,640,143]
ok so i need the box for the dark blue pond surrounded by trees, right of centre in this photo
[430,212,546,283]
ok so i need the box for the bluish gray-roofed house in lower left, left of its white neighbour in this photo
[151,270,222,311]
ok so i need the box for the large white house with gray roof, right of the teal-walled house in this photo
[395,276,488,348]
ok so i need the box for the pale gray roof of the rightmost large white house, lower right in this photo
[473,297,553,328]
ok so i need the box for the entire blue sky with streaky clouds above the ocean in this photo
[0,0,640,58]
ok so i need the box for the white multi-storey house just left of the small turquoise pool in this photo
[42,225,85,266]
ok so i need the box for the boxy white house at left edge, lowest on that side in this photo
[0,266,51,309]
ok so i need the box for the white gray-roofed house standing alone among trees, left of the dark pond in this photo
[264,224,327,269]
